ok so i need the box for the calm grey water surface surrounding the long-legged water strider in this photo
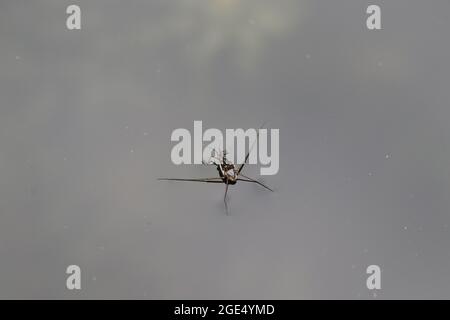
[0,0,450,299]
